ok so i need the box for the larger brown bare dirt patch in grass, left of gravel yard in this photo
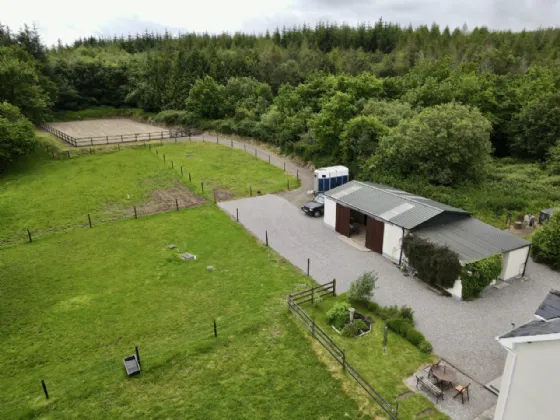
[136,183,208,214]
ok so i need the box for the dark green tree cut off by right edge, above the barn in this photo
[513,92,560,159]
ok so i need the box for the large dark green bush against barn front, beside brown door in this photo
[403,234,462,289]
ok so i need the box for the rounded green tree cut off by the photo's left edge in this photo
[0,102,36,168]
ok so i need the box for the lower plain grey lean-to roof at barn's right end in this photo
[413,217,531,262]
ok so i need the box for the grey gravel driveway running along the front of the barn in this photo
[220,195,560,384]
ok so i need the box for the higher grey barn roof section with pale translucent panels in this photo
[325,181,469,229]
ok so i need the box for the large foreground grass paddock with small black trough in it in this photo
[0,206,369,419]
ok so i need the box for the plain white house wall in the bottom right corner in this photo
[494,340,560,420]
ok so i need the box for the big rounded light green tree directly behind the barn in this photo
[380,103,492,185]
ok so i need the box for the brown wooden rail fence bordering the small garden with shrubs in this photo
[288,280,399,420]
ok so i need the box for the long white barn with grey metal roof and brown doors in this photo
[324,181,531,298]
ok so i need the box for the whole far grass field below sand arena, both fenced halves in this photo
[0,143,296,243]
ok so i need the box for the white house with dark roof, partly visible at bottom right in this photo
[494,290,560,420]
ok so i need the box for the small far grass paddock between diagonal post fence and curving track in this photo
[151,141,299,199]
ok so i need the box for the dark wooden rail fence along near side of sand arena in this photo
[41,125,188,147]
